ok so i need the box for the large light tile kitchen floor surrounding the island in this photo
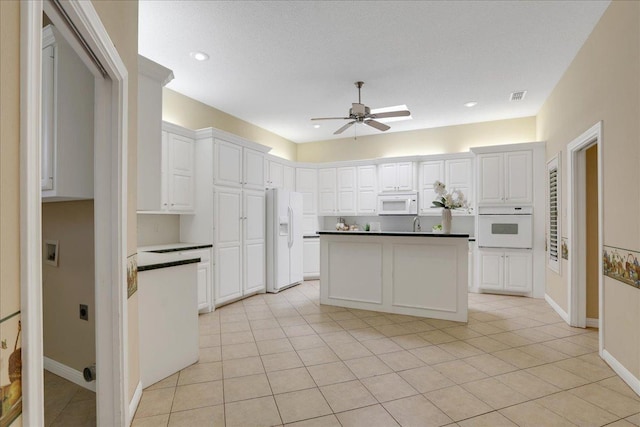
[133,281,640,427]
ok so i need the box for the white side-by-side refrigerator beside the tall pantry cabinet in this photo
[267,188,303,292]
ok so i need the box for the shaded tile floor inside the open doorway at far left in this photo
[44,371,96,427]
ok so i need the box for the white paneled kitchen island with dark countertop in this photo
[318,231,469,322]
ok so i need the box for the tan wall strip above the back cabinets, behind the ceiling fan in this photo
[297,117,536,162]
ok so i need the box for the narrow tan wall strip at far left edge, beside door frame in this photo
[0,1,22,426]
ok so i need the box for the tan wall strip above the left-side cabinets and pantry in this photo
[162,88,296,160]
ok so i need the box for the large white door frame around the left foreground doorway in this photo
[20,0,131,426]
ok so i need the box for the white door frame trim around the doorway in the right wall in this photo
[567,121,604,356]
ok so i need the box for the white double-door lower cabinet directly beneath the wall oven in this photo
[478,249,533,294]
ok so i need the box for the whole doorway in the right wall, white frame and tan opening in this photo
[567,122,604,356]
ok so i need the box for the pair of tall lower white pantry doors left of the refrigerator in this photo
[214,187,266,306]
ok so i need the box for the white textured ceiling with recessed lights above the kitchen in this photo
[139,0,609,142]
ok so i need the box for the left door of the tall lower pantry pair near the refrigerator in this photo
[214,188,243,305]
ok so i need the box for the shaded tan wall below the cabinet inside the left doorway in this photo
[42,200,96,371]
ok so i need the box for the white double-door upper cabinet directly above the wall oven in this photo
[477,150,533,205]
